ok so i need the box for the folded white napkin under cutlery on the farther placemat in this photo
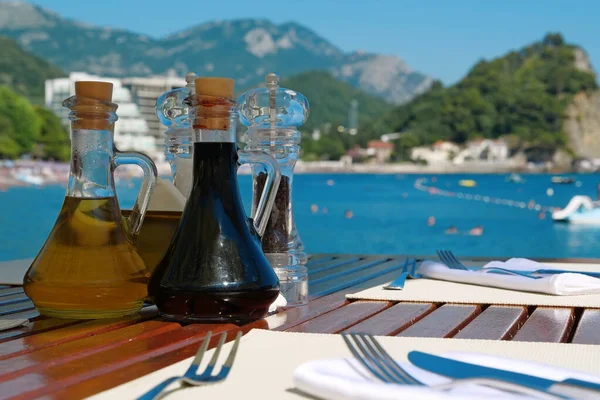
[419,260,600,296]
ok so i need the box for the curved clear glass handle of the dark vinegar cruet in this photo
[238,150,281,237]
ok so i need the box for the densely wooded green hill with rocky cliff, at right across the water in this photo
[365,34,597,154]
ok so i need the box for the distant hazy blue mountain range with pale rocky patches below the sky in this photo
[0,1,433,104]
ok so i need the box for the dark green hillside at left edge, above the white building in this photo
[0,37,65,104]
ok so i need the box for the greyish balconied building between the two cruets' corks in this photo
[122,73,186,142]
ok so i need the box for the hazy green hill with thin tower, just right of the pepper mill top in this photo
[281,71,392,159]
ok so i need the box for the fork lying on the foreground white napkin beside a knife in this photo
[342,333,564,399]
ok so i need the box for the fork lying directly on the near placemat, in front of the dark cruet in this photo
[137,331,242,400]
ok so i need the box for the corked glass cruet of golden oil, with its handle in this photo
[24,82,157,319]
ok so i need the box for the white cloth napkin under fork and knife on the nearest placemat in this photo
[293,353,600,400]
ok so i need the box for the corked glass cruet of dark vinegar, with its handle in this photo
[148,78,281,323]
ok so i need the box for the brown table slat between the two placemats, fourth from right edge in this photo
[396,304,481,338]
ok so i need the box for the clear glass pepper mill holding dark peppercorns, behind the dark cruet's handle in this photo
[238,73,309,306]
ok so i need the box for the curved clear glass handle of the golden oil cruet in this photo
[113,150,158,241]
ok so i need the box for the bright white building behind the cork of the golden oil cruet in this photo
[45,72,157,159]
